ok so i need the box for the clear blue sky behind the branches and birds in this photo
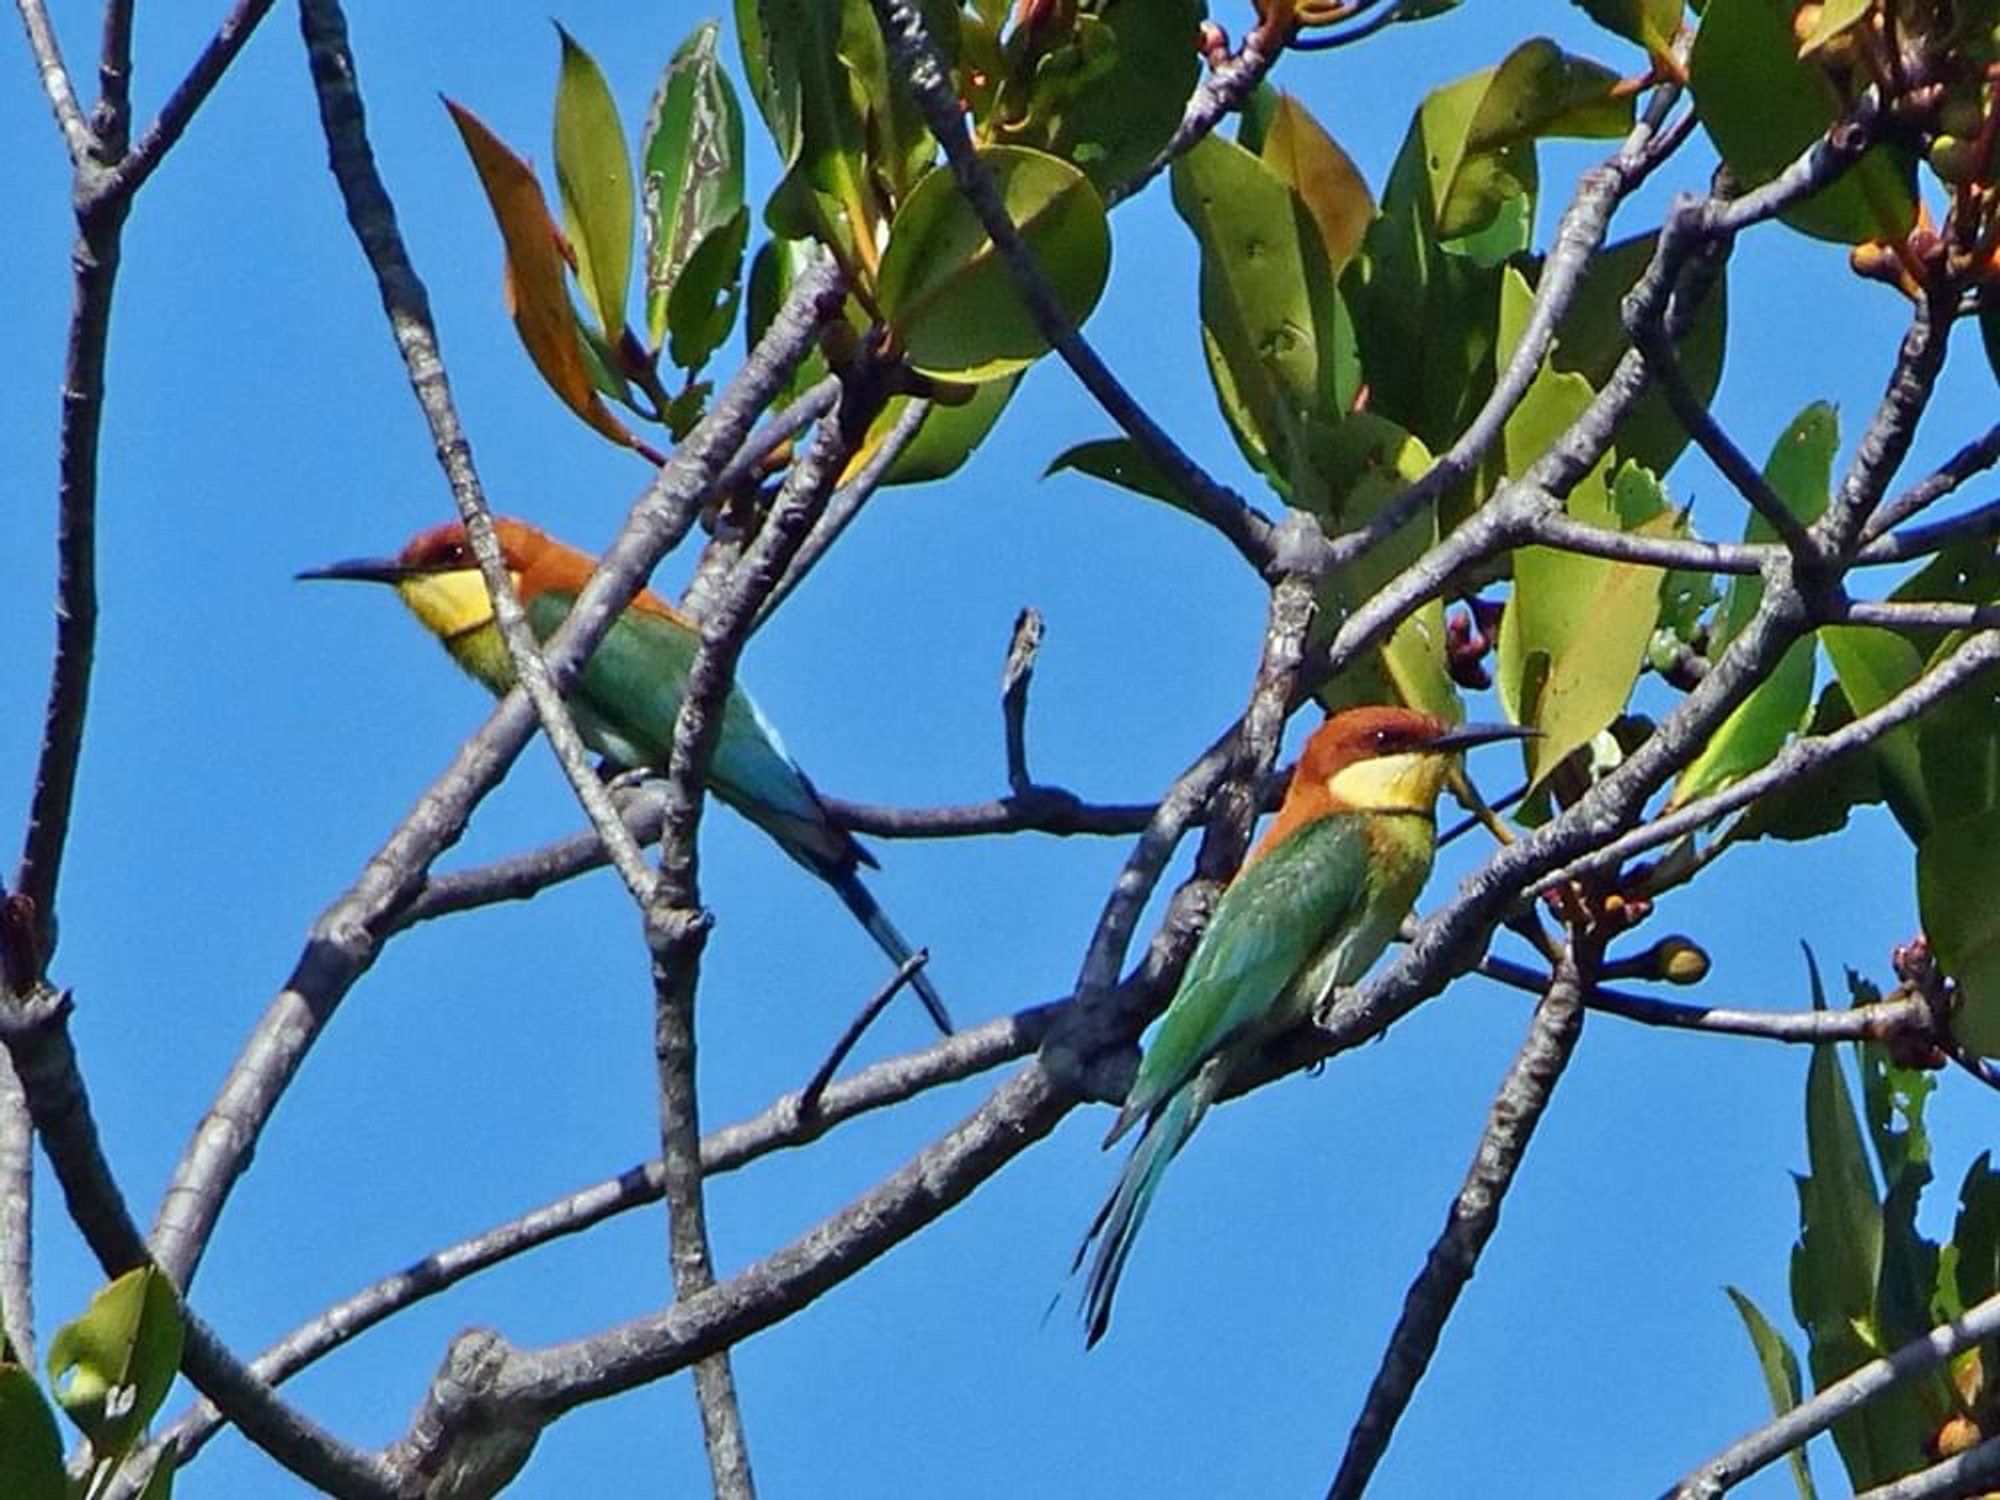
[0,0,1992,1500]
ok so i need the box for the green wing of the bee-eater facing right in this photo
[1112,812,1376,1138]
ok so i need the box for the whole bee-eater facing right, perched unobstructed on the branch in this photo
[1076,708,1534,1344]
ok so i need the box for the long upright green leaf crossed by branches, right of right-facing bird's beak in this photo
[1668,402,1840,806]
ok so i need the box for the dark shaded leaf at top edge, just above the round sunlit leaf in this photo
[996,0,1202,192]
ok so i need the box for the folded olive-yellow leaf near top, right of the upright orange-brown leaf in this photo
[1418,38,1632,240]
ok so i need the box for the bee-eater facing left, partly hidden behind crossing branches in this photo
[298,518,952,1032]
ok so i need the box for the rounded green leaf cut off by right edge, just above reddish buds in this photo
[1916,808,2000,1058]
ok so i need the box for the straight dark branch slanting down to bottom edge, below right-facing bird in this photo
[1326,952,1590,1500]
